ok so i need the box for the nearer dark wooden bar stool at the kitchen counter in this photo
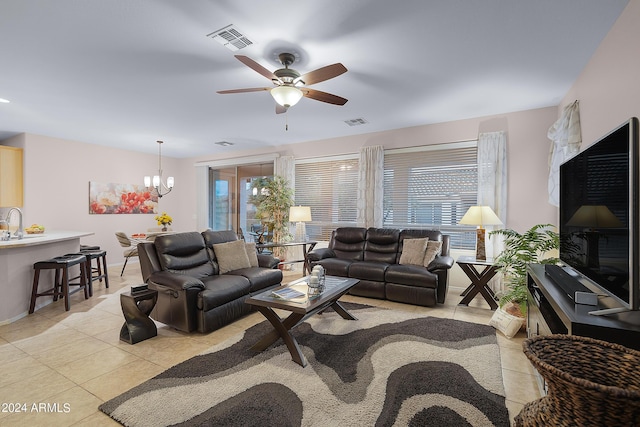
[29,254,89,314]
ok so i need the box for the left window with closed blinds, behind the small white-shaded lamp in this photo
[295,155,358,240]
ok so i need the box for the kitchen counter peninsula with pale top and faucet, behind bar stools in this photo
[0,231,93,325]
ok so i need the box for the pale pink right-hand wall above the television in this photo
[559,0,640,148]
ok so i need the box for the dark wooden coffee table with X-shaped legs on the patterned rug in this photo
[245,276,359,367]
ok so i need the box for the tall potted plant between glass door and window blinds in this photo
[252,175,293,258]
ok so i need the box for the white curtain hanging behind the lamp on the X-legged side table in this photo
[478,131,507,291]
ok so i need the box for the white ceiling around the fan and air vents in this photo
[0,0,628,157]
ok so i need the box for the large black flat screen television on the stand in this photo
[559,117,640,314]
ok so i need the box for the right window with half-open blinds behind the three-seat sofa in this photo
[383,141,478,250]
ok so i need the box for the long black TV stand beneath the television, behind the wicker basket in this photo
[527,264,640,350]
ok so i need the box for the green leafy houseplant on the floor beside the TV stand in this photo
[489,224,560,315]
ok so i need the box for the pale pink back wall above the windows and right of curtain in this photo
[189,107,557,231]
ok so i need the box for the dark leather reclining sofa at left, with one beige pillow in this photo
[138,230,282,333]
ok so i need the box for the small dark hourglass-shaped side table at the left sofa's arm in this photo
[120,289,158,344]
